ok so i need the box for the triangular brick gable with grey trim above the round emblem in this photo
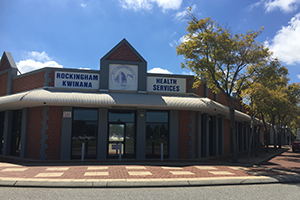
[101,38,146,62]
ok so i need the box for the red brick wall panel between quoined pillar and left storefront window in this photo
[46,106,62,160]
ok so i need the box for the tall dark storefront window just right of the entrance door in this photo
[146,111,169,158]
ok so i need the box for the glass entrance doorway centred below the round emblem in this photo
[108,111,135,158]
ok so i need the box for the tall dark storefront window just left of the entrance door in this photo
[72,109,98,159]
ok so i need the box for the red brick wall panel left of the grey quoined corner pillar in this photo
[26,107,44,159]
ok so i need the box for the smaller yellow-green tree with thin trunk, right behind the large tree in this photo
[241,59,289,151]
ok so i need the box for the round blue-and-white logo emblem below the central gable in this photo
[110,65,136,89]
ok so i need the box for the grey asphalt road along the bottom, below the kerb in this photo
[0,183,300,200]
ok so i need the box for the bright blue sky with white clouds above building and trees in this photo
[0,0,300,83]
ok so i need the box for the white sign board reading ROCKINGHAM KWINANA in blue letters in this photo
[54,71,100,89]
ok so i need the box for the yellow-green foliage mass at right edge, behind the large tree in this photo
[242,59,300,133]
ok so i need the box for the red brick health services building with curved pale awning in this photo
[0,39,264,160]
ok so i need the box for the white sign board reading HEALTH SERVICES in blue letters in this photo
[147,76,186,93]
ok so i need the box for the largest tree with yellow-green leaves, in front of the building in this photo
[176,8,270,162]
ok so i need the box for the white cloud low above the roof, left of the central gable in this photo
[17,51,63,73]
